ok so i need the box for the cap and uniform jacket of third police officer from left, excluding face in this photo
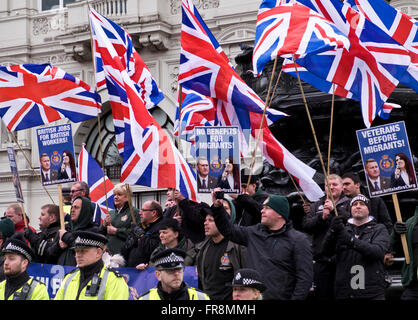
[139,248,209,300]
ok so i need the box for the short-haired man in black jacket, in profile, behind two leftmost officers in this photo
[24,204,60,264]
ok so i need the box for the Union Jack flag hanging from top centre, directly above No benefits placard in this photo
[178,0,272,113]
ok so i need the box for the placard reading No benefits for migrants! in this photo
[194,126,241,193]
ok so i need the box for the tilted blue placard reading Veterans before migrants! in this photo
[357,121,417,197]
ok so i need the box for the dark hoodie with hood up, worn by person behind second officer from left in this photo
[48,197,100,266]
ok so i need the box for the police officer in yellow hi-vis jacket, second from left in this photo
[55,231,129,300]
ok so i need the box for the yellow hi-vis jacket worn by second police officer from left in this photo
[54,266,129,300]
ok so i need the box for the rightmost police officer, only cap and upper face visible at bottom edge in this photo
[231,269,266,300]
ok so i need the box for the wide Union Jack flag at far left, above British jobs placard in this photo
[0,64,101,131]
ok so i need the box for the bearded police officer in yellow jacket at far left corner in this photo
[0,232,49,300]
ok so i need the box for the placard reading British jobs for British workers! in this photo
[36,124,76,186]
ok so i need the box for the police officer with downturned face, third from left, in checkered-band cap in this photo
[139,248,209,300]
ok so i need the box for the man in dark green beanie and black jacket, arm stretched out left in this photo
[212,190,313,300]
